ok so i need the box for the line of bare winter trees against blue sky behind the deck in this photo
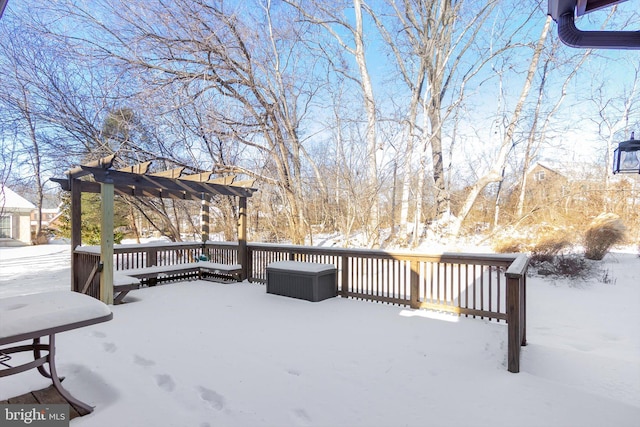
[0,0,640,247]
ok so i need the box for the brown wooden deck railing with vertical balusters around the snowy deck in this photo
[73,242,529,372]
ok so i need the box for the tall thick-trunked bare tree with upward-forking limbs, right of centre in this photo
[368,0,508,245]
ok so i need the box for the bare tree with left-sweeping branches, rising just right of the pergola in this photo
[47,1,330,243]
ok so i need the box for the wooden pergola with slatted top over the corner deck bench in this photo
[51,155,257,304]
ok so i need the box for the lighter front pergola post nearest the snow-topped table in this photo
[100,183,114,304]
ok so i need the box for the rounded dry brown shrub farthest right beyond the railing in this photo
[584,213,626,261]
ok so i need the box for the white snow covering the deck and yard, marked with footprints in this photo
[0,245,640,427]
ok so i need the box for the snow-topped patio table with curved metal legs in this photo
[0,291,113,415]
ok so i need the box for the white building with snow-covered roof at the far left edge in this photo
[0,186,36,246]
